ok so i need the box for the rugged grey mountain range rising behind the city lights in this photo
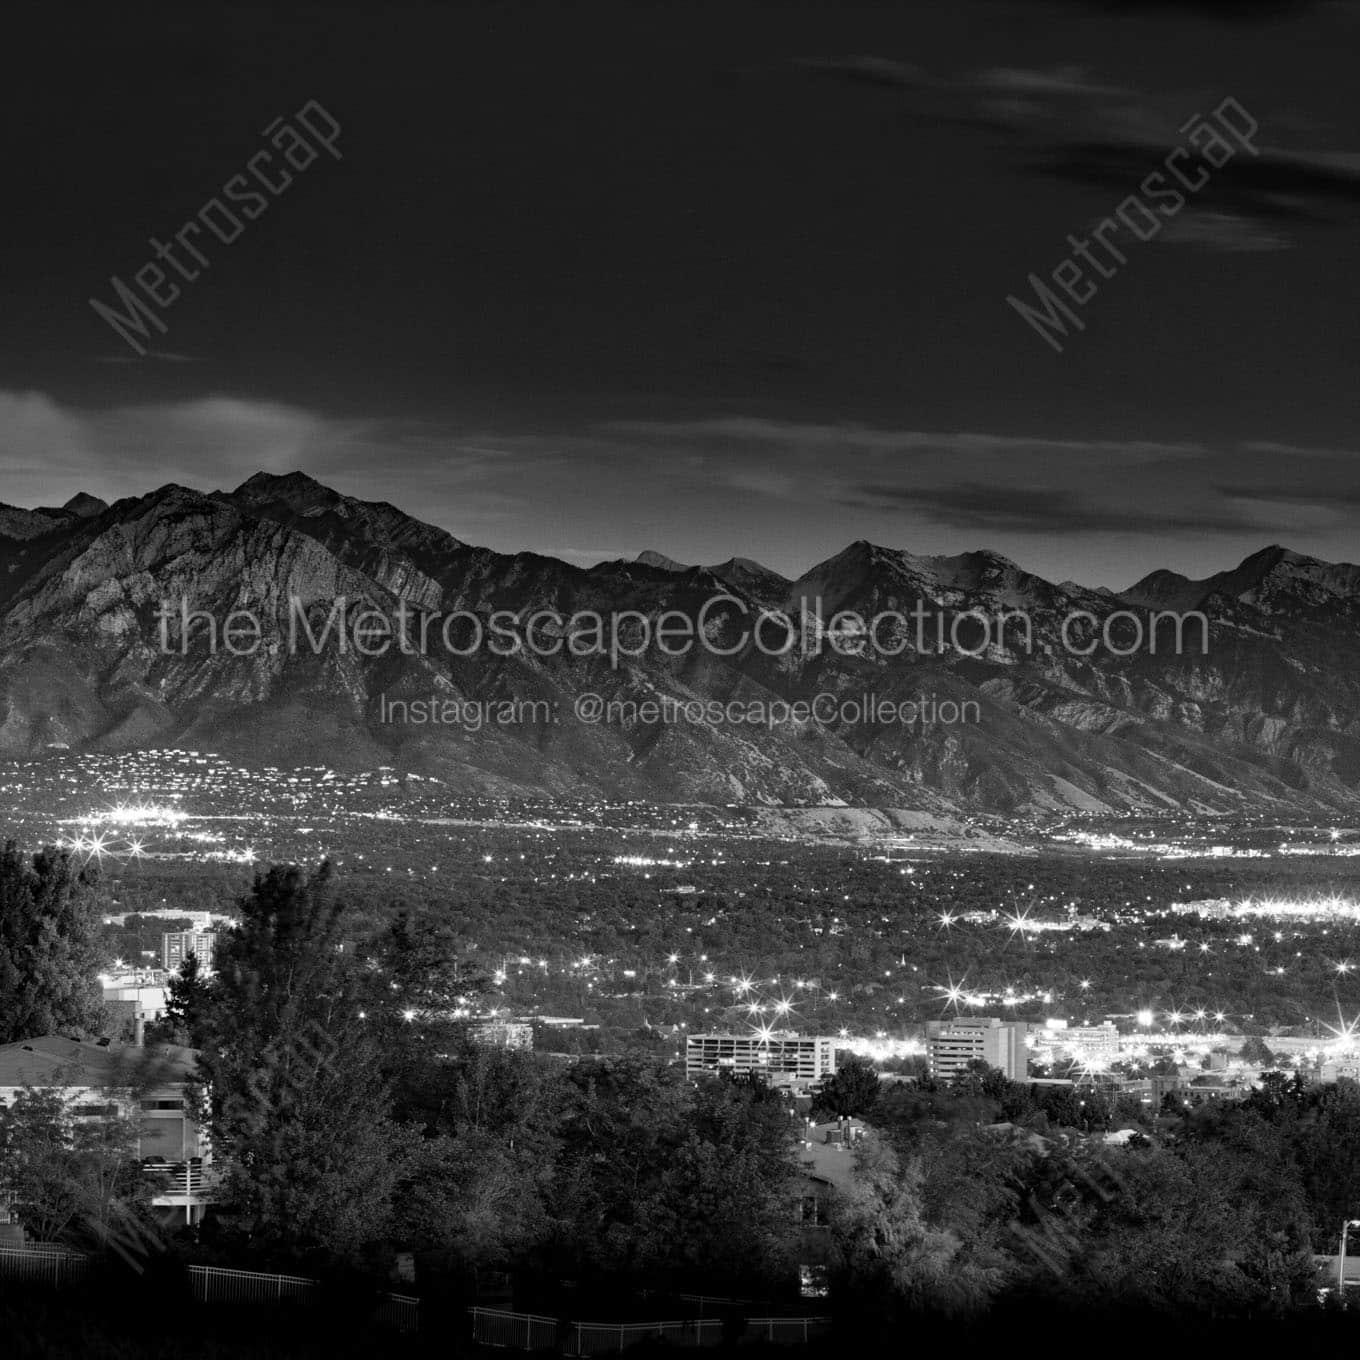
[0,473,1360,819]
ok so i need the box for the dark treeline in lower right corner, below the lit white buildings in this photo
[845,1070,1360,1314]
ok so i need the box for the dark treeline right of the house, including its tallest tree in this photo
[170,869,798,1291]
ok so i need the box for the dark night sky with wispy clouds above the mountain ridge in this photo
[0,0,1360,585]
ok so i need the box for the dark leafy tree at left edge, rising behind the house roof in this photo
[0,840,103,1043]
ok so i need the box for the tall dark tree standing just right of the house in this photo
[200,865,412,1261]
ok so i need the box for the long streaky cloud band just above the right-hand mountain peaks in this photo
[596,416,1357,541]
